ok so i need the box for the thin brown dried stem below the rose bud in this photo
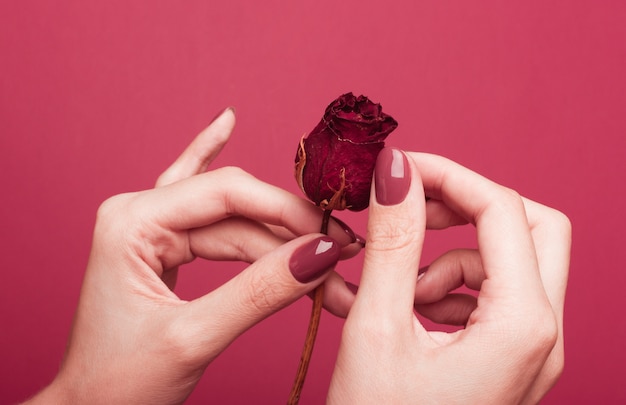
[287,209,332,405]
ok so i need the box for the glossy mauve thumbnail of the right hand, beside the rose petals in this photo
[374,148,411,205]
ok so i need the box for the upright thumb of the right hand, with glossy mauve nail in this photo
[351,148,426,322]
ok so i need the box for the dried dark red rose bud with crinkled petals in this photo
[296,93,398,211]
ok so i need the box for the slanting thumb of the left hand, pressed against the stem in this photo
[180,234,341,361]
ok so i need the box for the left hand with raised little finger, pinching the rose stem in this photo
[24,109,358,404]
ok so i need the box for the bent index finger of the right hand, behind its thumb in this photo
[409,153,545,300]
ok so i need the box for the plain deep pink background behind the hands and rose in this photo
[0,0,626,404]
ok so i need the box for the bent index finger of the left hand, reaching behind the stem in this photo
[138,167,354,246]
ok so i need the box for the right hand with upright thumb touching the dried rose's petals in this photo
[328,149,571,404]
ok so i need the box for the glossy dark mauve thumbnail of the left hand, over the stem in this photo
[289,236,341,283]
